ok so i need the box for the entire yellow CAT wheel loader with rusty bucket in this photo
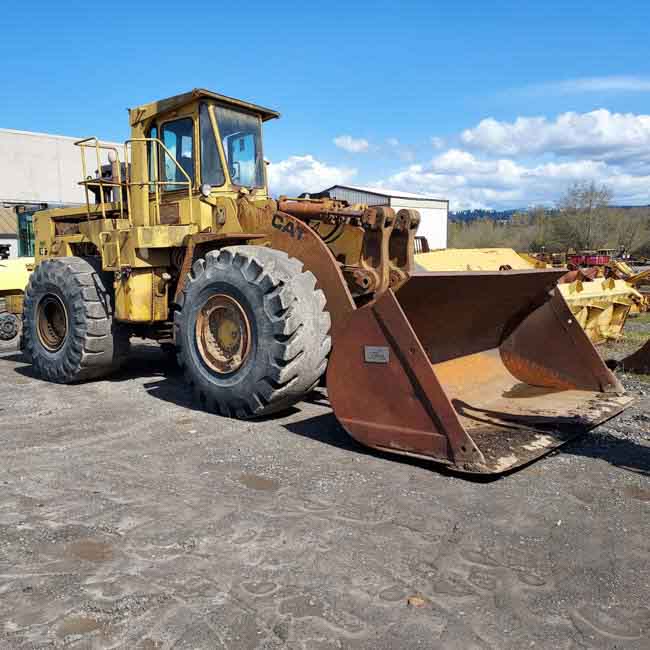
[24,89,630,473]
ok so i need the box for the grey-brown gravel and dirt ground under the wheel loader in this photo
[0,319,650,650]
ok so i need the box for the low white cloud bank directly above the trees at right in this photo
[378,149,650,210]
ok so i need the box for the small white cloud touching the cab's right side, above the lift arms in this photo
[267,155,357,196]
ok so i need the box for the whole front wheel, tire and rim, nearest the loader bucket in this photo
[174,246,331,419]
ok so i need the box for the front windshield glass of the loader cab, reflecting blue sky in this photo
[214,106,264,187]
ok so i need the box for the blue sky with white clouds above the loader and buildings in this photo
[0,0,650,208]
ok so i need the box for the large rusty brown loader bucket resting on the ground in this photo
[327,270,631,473]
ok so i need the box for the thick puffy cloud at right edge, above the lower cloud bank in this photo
[461,109,650,161]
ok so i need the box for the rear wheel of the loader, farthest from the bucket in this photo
[23,257,128,384]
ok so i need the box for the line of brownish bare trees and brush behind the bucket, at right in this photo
[448,182,650,256]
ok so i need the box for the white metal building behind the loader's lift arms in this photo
[311,185,449,249]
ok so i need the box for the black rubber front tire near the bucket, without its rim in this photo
[174,246,331,419]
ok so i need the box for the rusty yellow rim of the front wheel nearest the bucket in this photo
[196,294,251,375]
